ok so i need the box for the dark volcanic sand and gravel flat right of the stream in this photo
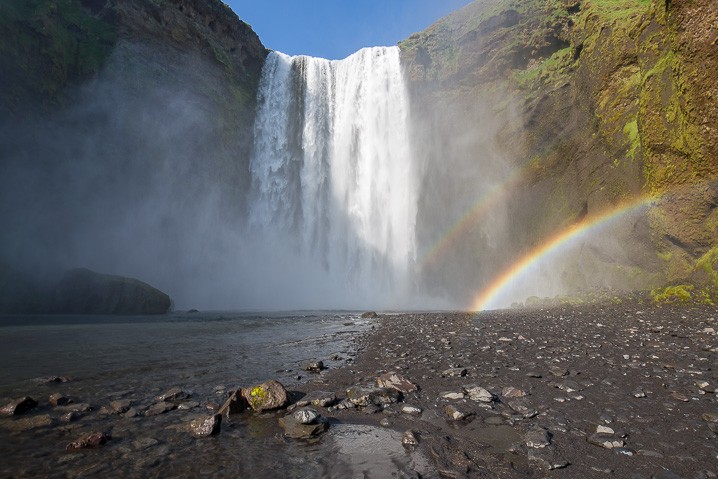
[302,301,718,478]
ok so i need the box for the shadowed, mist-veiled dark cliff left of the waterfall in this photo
[0,0,267,308]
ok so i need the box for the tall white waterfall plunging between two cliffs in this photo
[249,47,418,307]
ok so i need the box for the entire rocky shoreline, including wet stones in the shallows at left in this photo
[0,299,718,479]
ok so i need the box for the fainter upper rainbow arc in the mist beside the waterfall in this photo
[420,169,524,266]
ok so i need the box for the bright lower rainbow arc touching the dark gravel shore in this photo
[471,196,656,311]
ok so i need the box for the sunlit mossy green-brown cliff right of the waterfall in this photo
[400,0,718,304]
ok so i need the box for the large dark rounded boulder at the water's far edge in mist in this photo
[49,268,172,314]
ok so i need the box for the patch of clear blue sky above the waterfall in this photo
[224,0,471,60]
